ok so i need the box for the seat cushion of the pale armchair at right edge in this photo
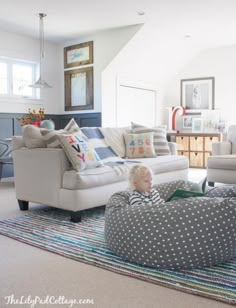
[207,154,236,170]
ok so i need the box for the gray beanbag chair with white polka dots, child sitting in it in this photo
[105,182,236,270]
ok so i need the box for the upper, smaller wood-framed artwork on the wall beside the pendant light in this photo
[64,41,93,68]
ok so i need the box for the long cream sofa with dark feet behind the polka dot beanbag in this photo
[13,119,189,222]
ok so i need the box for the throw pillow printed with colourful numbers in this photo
[124,132,156,158]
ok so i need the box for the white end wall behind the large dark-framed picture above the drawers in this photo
[165,46,236,124]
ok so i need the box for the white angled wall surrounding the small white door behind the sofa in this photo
[102,23,206,126]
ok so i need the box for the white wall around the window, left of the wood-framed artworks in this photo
[0,31,62,113]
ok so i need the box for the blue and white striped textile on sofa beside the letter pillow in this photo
[80,127,118,160]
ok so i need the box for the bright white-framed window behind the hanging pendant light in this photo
[0,58,38,98]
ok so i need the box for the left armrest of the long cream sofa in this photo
[13,148,70,206]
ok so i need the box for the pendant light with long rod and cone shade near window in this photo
[29,13,52,89]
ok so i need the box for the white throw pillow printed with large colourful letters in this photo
[57,133,103,171]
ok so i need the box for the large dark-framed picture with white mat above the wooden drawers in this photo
[180,77,215,112]
